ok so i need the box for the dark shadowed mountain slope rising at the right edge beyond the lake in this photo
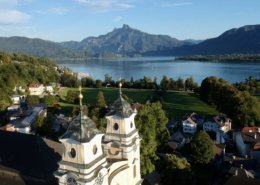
[172,25,260,55]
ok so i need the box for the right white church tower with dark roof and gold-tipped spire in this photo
[103,83,142,185]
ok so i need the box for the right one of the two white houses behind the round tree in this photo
[203,114,232,143]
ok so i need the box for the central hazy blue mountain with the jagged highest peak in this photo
[61,25,193,54]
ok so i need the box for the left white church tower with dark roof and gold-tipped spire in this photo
[54,88,108,185]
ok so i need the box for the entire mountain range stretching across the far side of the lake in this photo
[0,24,260,58]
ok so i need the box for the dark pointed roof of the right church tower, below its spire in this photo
[107,94,134,118]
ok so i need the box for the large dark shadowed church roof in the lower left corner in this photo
[0,131,63,184]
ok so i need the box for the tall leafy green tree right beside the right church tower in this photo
[135,103,168,175]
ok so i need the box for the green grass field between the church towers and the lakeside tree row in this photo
[60,88,217,119]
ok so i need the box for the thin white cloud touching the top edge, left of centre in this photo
[75,0,135,12]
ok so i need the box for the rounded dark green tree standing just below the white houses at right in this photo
[189,131,215,164]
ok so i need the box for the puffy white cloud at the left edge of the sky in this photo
[0,9,30,24]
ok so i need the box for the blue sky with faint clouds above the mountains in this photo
[0,0,260,42]
